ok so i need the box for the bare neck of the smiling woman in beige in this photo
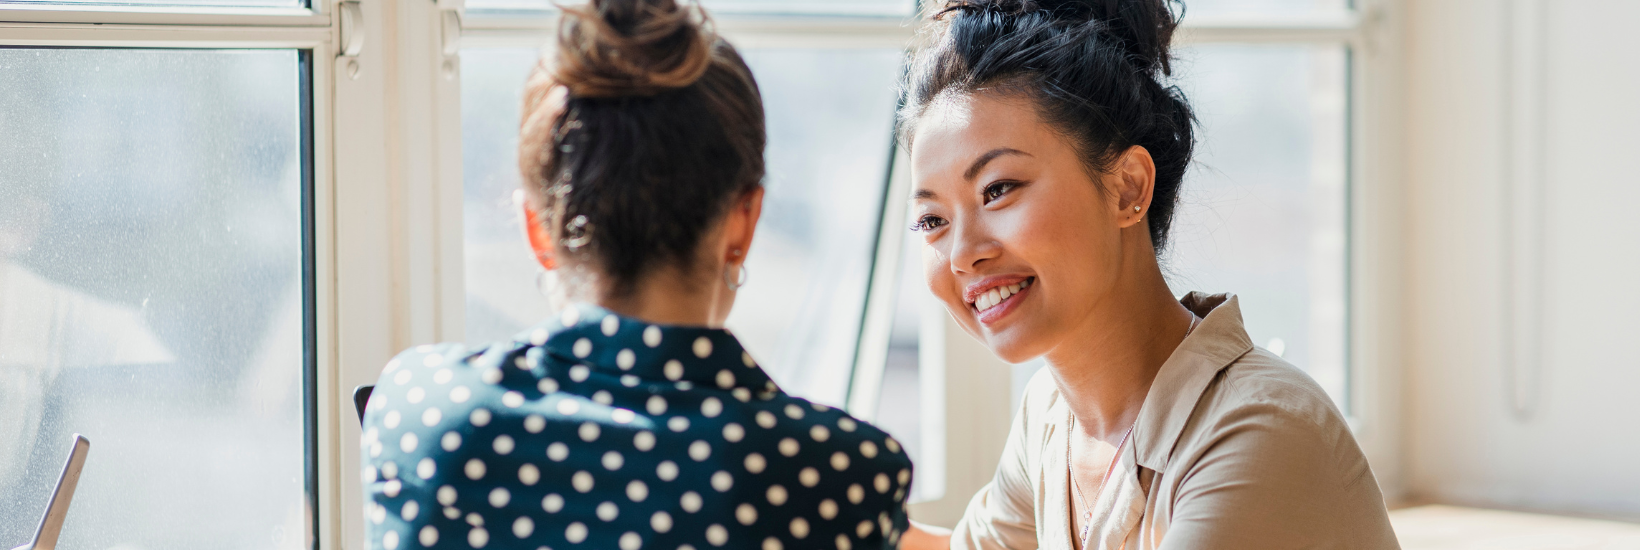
[1046,249,1194,445]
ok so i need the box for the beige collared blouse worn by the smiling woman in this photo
[951,292,1399,550]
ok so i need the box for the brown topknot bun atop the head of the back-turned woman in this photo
[553,0,717,97]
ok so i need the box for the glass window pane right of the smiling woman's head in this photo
[1164,44,1348,412]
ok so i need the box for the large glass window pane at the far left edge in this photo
[0,48,312,550]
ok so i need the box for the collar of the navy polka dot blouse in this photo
[520,304,779,401]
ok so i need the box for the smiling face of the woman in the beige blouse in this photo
[912,94,1148,363]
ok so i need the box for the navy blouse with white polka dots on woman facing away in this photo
[362,305,912,550]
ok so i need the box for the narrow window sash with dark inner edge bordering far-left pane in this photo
[0,3,349,548]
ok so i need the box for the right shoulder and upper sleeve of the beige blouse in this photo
[1168,348,1392,547]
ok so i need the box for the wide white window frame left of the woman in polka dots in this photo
[0,0,461,550]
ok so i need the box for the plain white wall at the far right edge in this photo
[1401,0,1640,519]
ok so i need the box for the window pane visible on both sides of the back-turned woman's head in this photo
[462,49,902,406]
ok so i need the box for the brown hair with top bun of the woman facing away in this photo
[518,0,768,296]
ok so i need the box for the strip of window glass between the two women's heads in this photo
[728,49,902,406]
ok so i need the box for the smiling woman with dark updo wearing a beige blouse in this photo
[902,0,1397,550]
